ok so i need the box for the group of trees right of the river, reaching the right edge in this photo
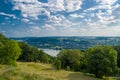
[54,46,120,78]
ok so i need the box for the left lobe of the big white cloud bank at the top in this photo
[13,0,45,19]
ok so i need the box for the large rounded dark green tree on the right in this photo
[87,46,117,78]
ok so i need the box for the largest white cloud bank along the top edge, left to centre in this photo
[13,0,82,19]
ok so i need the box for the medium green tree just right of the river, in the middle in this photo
[57,49,83,71]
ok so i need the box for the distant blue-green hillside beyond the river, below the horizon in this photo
[11,36,120,49]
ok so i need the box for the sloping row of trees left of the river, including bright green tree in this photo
[0,34,54,65]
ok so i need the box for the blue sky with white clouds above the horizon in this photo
[0,0,120,37]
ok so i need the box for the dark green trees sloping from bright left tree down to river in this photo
[19,42,54,63]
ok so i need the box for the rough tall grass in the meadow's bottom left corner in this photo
[0,66,53,80]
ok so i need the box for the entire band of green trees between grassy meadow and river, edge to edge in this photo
[0,34,120,80]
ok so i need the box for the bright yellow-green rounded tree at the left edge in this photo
[0,40,21,65]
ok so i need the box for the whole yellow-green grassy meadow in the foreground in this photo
[0,62,100,80]
